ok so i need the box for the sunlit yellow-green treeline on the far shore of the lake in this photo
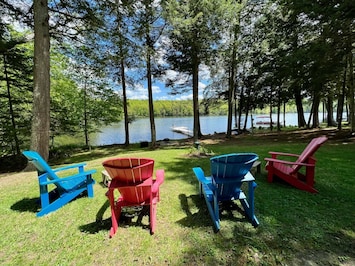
[128,100,309,118]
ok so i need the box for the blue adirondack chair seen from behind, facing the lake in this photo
[193,153,259,231]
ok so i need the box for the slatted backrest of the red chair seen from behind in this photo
[102,158,154,184]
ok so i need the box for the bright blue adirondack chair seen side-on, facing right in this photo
[23,151,96,217]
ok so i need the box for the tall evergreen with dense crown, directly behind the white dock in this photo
[164,0,228,141]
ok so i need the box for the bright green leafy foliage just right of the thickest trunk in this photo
[51,52,122,147]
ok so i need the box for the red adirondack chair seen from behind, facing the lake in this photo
[103,158,164,237]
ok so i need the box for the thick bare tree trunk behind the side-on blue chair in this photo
[31,0,50,160]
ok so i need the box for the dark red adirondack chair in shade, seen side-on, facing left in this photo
[265,136,328,193]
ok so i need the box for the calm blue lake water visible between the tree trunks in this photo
[91,113,322,146]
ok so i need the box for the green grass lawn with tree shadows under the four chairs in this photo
[0,129,355,265]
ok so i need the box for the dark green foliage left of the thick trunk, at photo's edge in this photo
[0,26,33,156]
